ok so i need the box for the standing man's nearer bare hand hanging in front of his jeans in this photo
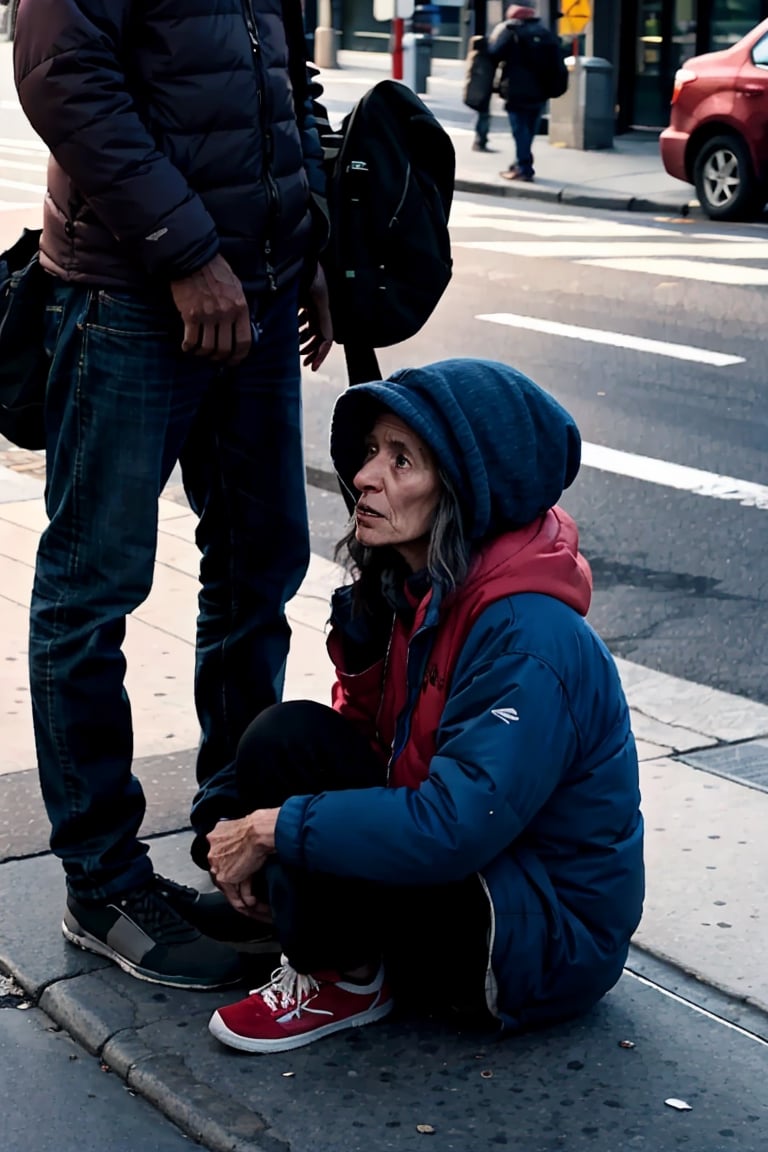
[170,256,251,364]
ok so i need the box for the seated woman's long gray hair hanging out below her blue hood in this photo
[335,468,469,592]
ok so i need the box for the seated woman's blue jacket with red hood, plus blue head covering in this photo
[276,361,644,1029]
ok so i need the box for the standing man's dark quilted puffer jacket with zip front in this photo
[14,0,321,291]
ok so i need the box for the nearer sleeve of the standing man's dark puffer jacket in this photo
[14,0,219,279]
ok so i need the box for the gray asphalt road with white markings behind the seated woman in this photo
[305,196,768,702]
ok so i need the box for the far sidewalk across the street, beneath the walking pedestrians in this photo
[320,52,701,215]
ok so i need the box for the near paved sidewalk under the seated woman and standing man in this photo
[0,457,768,1152]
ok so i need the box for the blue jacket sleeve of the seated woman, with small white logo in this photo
[276,629,578,885]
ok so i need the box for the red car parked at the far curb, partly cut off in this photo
[660,20,768,220]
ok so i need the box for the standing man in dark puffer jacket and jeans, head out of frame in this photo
[14,0,332,988]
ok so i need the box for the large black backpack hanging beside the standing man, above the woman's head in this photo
[322,79,455,359]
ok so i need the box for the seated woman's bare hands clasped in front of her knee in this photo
[208,808,280,919]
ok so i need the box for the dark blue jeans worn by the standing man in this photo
[30,282,309,900]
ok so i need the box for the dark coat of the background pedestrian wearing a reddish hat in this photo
[488,17,568,112]
